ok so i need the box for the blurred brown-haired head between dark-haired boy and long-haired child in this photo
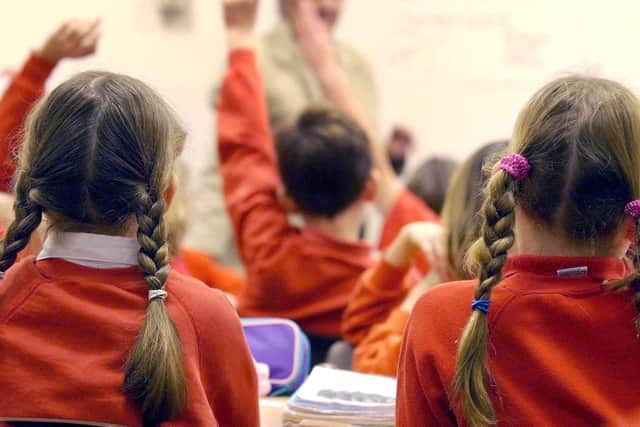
[407,157,456,214]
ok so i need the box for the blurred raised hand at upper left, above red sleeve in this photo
[36,19,101,64]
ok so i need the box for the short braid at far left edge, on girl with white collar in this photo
[0,174,42,272]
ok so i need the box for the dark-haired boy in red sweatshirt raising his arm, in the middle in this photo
[218,0,437,361]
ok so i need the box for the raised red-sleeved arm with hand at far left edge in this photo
[0,20,100,192]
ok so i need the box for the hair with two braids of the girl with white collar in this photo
[0,72,186,425]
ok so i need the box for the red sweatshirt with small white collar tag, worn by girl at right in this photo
[397,256,640,427]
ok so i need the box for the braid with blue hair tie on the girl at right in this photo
[453,170,515,426]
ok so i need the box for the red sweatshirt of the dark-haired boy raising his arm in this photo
[218,51,435,337]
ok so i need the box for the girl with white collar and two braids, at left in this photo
[0,72,258,426]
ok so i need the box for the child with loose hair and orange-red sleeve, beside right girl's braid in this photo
[342,141,507,376]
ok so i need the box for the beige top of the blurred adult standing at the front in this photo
[186,21,377,266]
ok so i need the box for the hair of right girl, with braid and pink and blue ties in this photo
[454,76,640,425]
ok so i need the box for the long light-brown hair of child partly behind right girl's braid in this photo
[442,141,508,279]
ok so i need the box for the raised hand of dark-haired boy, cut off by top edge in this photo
[223,0,258,50]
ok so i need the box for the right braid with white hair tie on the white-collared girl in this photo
[124,193,187,426]
